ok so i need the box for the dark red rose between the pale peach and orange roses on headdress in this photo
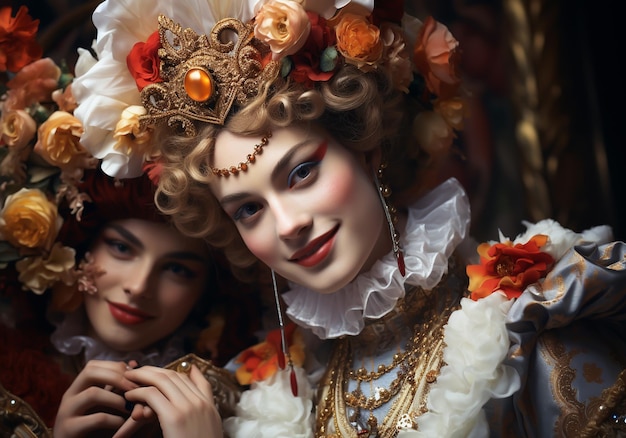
[291,12,335,86]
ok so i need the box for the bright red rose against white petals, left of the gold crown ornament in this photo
[126,31,163,91]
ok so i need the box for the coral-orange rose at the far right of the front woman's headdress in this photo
[413,17,460,98]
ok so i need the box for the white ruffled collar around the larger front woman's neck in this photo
[284,178,470,339]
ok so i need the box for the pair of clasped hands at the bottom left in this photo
[54,360,223,438]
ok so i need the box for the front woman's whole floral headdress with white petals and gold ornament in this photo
[74,0,465,178]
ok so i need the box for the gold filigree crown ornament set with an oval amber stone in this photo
[141,15,279,136]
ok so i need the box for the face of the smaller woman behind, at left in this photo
[85,219,209,351]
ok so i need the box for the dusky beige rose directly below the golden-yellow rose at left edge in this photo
[15,242,76,295]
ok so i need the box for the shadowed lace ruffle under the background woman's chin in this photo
[50,310,185,367]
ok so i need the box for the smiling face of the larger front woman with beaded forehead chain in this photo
[211,126,391,293]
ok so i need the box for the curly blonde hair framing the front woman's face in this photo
[156,65,432,280]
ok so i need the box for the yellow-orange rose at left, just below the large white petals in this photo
[34,111,87,168]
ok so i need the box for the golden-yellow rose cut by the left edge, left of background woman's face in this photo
[0,188,61,249]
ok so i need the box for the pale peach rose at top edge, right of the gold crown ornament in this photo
[254,0,311,60]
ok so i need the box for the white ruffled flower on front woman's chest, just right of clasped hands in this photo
[224,367,315,438]
